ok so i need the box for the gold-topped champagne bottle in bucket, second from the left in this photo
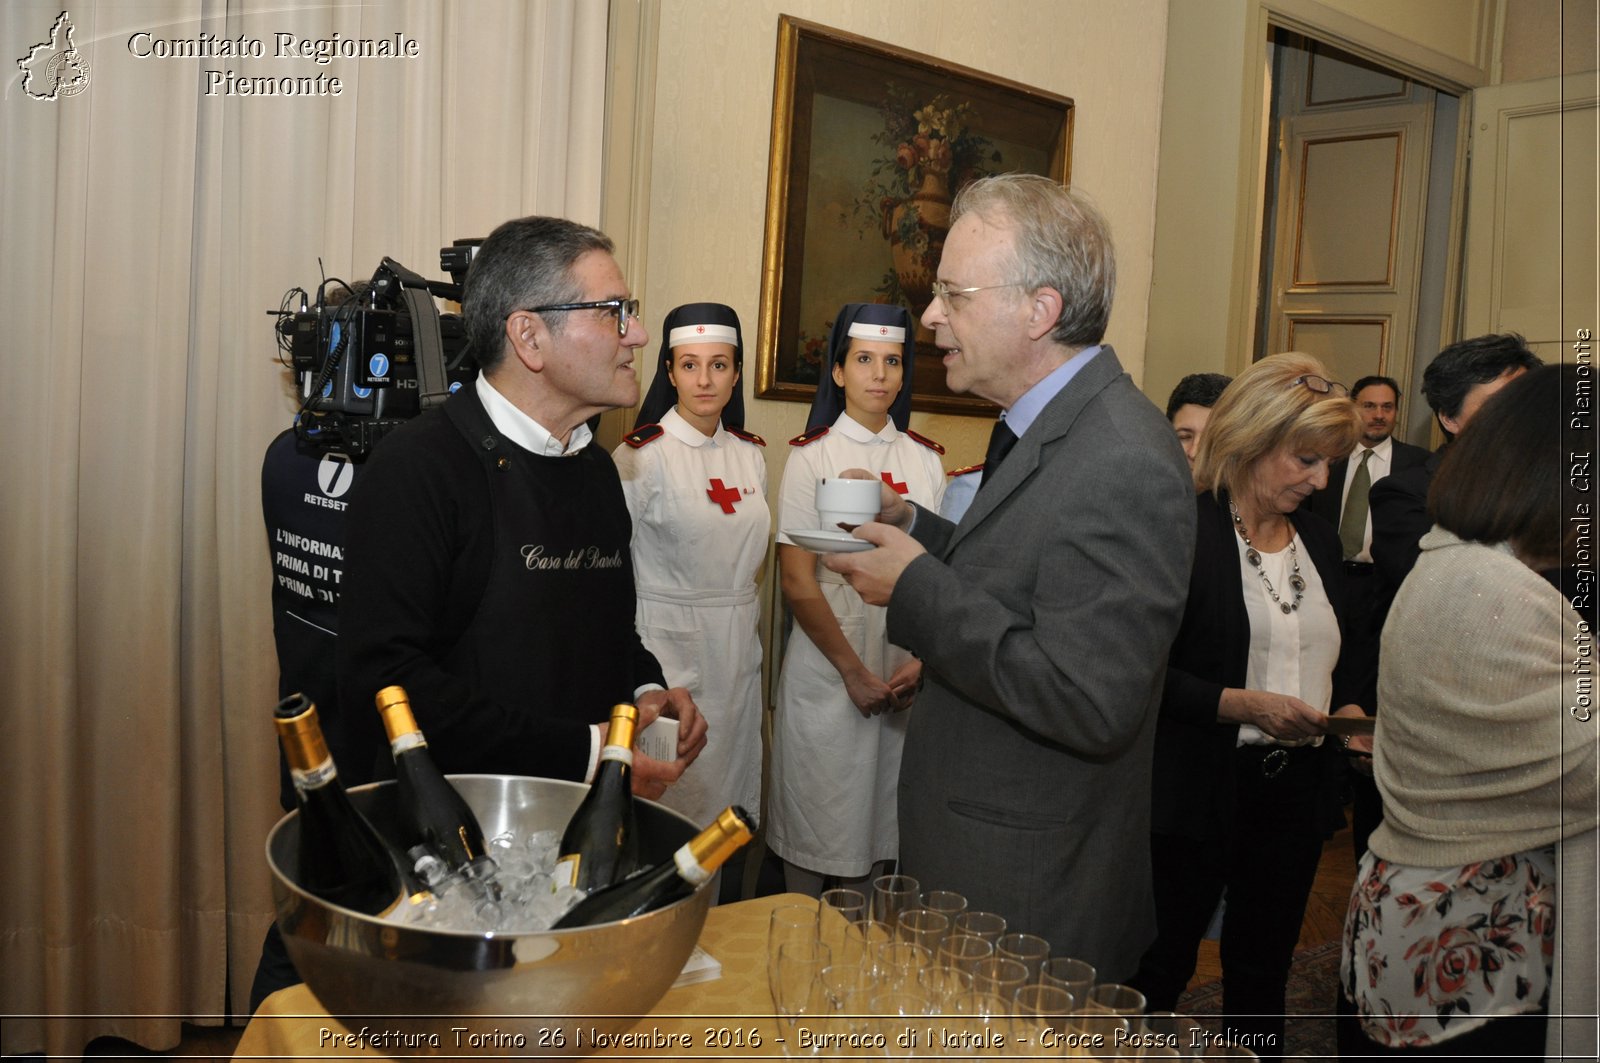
[376,687,494,880]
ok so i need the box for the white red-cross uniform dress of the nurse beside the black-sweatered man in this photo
[613,408,771,826]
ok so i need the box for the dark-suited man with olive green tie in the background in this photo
[1306,376,1429,860]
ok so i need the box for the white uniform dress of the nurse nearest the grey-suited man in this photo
[766,413,944,877]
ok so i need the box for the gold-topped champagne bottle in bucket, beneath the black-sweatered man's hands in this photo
[555,704,638,893]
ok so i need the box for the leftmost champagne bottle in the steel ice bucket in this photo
[274,693,426,916]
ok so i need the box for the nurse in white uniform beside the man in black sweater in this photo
[613,303,771,851]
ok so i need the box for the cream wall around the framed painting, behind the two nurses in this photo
[645,0,1166,473]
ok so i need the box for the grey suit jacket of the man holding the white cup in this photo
[888,347,1195,981]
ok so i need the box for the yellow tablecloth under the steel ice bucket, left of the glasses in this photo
[234,893,800,1060]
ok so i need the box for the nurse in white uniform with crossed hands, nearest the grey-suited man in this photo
[766,303,944,895]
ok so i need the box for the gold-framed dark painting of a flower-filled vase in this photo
[755,14,1072,416]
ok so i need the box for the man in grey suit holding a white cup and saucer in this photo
[827,174,1195,981]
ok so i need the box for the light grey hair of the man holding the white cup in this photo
[950,173,1117,347]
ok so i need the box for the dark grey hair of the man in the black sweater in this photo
[461,216,613,370]
